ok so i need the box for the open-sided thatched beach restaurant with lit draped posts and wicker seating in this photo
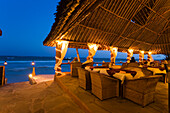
[43,0,170,112]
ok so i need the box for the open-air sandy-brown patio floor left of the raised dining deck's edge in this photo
[0,81,83,113]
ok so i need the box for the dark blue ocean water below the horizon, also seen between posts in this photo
[0,57,162,83]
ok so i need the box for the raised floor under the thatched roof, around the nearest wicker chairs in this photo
[58,75,168,113]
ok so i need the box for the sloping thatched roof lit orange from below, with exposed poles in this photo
[43,0,170,54]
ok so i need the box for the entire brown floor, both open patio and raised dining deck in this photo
[0,75,168,113]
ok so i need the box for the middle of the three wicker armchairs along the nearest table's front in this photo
[90,72,119,100]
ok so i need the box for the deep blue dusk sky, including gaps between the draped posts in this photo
[0,0,165,58]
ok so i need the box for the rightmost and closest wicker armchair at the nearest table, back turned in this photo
[123,76,161,107]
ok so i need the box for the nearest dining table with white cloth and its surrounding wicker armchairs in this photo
[73,63,167,107]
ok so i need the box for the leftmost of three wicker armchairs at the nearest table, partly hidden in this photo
[77,67,91,90]
